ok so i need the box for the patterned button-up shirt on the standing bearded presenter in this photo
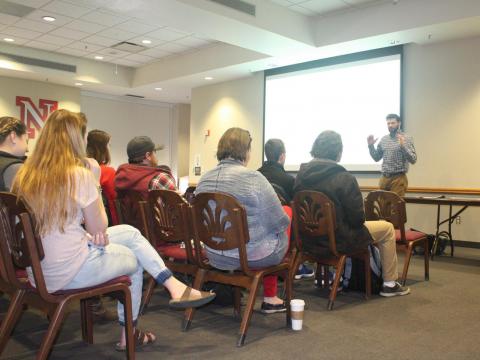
[368,132,417,176]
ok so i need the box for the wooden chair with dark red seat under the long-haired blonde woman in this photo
[0,192,135,359]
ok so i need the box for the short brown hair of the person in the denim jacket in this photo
[217,128,252,161]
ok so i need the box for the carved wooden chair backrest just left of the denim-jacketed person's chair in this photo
[142,190,194,262]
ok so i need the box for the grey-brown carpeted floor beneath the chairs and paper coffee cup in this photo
[0,248,480,360]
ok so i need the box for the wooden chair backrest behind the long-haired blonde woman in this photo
[0,192,52,299]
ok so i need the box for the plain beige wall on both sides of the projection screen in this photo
[190,38,480,241]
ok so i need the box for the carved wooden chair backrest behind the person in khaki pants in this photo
[292,190,338,255]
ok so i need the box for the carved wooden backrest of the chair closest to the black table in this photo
[365,190,407,239]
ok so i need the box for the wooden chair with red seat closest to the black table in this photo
[365,190,429,285]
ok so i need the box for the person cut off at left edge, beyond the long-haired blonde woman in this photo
[0,116,28,191]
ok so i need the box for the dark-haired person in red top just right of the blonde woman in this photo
[87,130,118,225]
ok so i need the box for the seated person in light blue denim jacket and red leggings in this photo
[195,128,290,313]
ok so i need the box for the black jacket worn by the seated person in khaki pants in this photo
[294,159,372,253]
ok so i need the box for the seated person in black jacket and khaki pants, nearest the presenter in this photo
[294,131,410,297]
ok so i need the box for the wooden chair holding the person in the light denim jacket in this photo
[184,193,292,346]
